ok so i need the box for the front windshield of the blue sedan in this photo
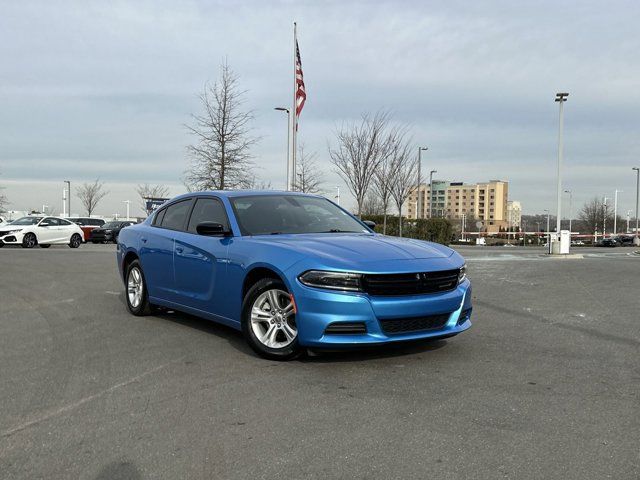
[230,195,369,235]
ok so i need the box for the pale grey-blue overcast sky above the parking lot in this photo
[0,0,640,216]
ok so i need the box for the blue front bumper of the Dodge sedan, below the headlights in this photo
[292,279,472,348]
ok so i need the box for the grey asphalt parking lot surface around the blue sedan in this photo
[0,245,640,480]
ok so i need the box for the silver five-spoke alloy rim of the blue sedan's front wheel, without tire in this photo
[251,289,298,349]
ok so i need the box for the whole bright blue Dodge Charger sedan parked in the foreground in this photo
[117,191,471,360]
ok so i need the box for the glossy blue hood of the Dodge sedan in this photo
[246,233,453,264]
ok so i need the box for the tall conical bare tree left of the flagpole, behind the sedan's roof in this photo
[185,61,258,190]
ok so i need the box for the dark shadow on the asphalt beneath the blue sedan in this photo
[118,292,447,363]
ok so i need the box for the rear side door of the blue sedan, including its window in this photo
[140,198,193,302]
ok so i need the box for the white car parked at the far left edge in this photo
[0,216,84,248]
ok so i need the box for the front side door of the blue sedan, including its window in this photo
[173,197,231,315]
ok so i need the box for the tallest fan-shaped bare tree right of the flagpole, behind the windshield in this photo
[329,112,390,215]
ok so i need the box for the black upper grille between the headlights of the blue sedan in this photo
[362,268,460,296]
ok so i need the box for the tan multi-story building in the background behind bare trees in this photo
[407,180,520,232]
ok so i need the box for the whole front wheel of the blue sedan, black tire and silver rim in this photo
[242,278,302,360]
